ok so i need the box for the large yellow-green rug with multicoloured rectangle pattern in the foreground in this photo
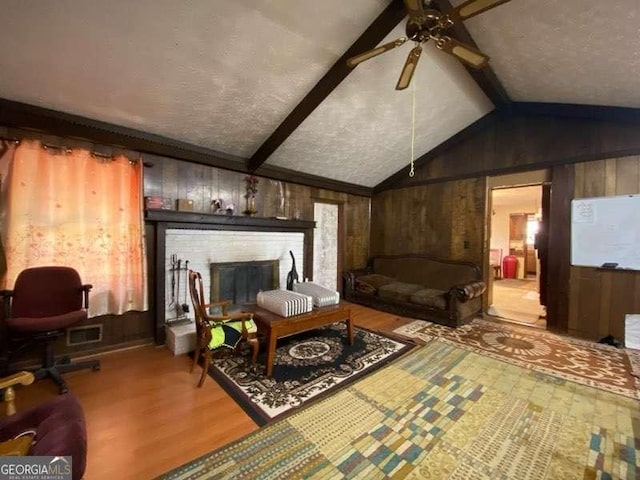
[161,341,640,480]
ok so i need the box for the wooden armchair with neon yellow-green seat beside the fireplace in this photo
[189,270,258,387]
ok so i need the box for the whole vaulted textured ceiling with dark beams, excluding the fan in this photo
[0,0,640,193]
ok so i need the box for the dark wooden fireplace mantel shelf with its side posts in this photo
[144,209,316,344]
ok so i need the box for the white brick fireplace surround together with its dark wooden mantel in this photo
[145,210,315,343]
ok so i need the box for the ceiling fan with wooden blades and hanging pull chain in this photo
[347,0,509,90]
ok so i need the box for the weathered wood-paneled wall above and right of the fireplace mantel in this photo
[144,155,370,270]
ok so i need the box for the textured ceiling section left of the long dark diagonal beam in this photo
[0,0,387,157]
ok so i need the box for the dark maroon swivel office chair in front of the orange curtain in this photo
[1,267,100,393]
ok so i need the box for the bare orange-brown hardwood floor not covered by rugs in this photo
[8,305,411,480]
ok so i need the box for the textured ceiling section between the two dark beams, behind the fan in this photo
[267,25,493,187]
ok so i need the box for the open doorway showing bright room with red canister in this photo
[487,184,546,328]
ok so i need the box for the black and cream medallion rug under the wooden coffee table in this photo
[209,322,415,425]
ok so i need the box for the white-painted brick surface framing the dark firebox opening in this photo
[165,229,304,320]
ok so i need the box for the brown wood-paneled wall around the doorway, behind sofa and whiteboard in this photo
[378,113,640,340]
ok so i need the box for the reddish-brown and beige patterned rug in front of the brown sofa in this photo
[394,319,640,398]
